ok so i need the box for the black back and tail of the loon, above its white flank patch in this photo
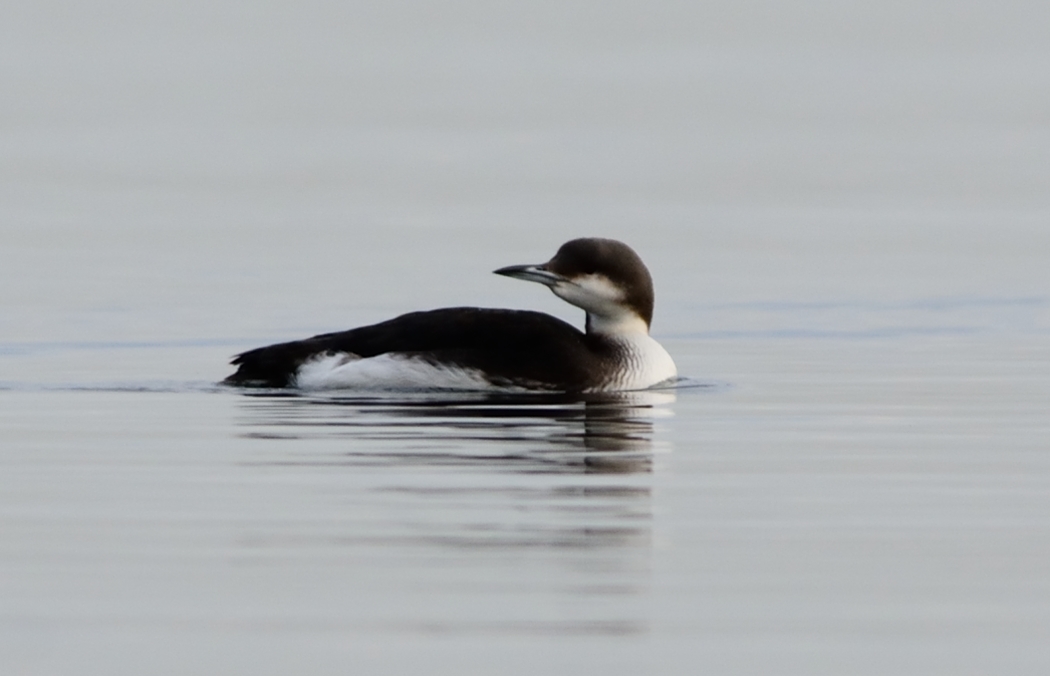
[225,308,615,392]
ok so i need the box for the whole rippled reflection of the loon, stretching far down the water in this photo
[228,392,675,637]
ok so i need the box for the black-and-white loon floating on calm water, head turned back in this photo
[224,237,677,393]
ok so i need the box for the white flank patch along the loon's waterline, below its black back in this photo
[295,353,492,389]
